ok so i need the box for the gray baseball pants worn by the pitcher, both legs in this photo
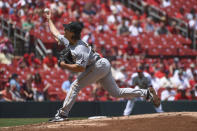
[60,58,147,116]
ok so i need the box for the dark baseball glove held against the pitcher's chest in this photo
[58,48,75,66]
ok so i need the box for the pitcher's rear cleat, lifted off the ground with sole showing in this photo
[146,87,161,107]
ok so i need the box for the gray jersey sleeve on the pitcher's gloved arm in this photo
[76,46,89,68]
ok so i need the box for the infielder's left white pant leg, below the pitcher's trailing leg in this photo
[123,98,136,116]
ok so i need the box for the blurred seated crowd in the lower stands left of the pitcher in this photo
[0,44,59,101]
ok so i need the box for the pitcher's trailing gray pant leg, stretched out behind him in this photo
[99,70,147,99]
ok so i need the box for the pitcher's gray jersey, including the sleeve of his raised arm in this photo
[58,35,99,68]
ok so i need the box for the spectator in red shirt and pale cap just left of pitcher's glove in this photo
[43,49,58,70]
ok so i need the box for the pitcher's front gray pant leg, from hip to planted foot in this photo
[60,58,110,116]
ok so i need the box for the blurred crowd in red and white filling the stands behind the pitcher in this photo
[0,0,197,101]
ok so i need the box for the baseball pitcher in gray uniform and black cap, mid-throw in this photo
[45,11,160,122]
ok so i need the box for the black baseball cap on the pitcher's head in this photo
[63,22,83,34]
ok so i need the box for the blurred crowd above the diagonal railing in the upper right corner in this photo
[142,0,197,32]
